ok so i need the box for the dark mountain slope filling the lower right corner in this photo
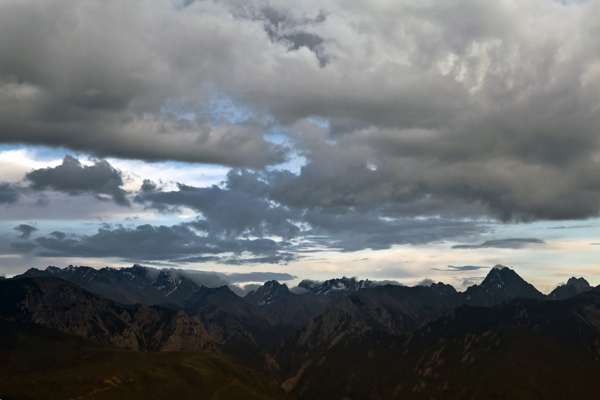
[291,288,600,400]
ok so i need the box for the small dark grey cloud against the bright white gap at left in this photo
[25,155,129,206]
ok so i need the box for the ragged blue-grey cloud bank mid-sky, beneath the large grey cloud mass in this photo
[134,170,485,252]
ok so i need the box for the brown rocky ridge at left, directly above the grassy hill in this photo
[0,277,218,351]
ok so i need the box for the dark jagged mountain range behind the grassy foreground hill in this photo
[0,265,600,399]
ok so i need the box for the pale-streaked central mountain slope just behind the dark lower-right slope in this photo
[274,285,458,390]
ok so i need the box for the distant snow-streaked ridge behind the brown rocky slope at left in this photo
[13,264,200,310]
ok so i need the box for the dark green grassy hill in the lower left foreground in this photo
[0,321,287,400]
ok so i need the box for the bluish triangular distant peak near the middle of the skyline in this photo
[244,281,331,336]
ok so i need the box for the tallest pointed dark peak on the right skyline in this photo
[461,265,545,307]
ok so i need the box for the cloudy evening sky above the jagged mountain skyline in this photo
[0,0,600,292]
